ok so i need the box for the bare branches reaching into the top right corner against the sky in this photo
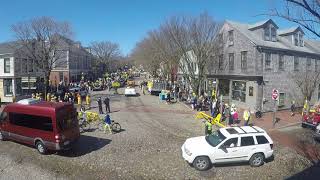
[271,0,320,37]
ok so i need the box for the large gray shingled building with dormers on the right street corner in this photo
[208,19,320,111]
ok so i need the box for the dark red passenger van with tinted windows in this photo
[0,98,80,154]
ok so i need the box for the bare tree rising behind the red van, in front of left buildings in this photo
[12,17,72,94]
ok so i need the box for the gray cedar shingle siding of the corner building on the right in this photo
[218,20,320,111]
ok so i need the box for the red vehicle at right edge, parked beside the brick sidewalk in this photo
[301,104,320,129]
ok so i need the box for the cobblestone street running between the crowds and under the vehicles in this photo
[0,79,318,179]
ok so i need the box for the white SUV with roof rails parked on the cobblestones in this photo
[181,126,273,171]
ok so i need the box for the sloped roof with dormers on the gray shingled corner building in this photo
[226,21,320,55]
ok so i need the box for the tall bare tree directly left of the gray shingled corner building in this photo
[162,13,221,94]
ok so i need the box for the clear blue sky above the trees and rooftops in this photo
[0,0,310,54]
